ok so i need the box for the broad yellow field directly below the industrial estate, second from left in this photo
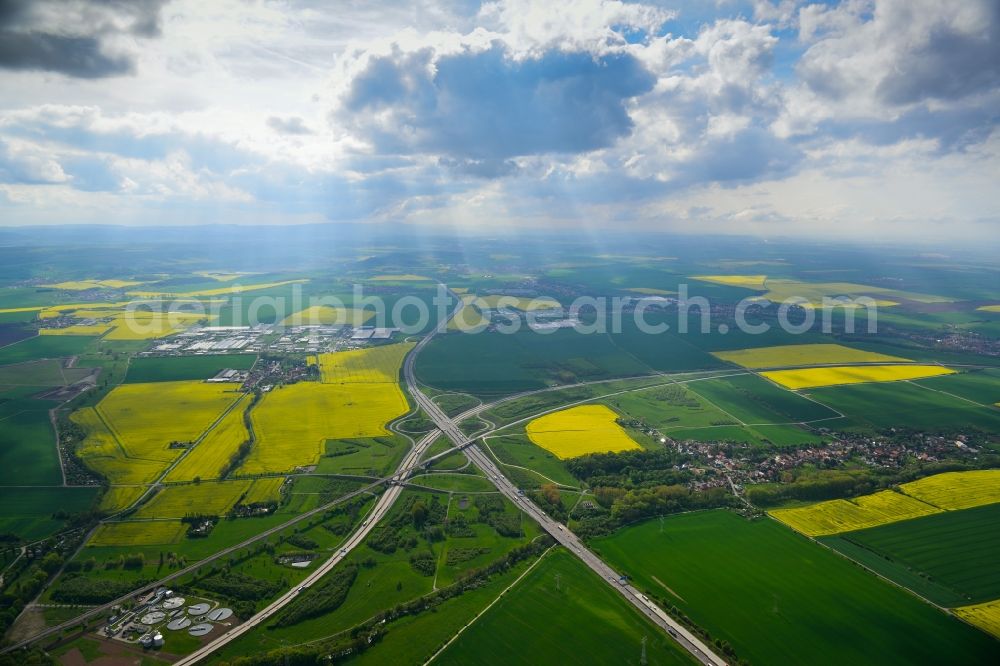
[97,381,242,462]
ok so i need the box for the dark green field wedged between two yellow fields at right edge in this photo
[824,504,1000,606]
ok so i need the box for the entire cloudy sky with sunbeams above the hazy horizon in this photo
[0,0,1000,242]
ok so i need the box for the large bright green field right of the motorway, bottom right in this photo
[593,510,997,664]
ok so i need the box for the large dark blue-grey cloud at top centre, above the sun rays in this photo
[337,42,655,160]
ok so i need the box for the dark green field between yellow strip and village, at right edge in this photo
[807,382,1000,432]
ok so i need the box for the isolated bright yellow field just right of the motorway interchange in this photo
[527,405,639,458]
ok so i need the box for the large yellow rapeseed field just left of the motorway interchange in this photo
[240,382,409,474]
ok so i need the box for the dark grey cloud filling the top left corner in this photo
[0,0,165,78]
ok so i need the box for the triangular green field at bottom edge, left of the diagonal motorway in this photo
[433,550,693,666]
